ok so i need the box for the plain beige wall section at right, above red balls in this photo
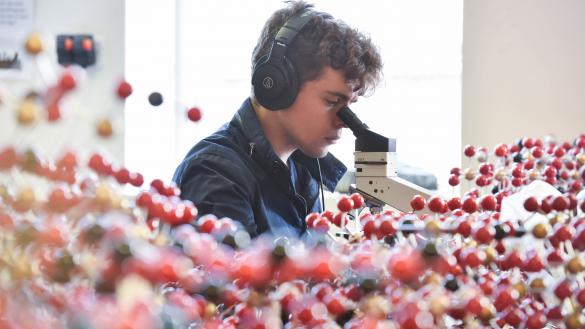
[462,0,585,150]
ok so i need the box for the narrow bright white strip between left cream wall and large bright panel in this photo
[124,0,176,182]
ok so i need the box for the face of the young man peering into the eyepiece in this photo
[278,67,357,158]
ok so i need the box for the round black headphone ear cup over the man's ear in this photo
[252,56,299,111]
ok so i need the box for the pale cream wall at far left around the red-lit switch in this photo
[0,0,124,163]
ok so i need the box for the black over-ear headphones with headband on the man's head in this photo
[252,10,313,111]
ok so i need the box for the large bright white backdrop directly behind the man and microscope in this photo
[173,0,463,191]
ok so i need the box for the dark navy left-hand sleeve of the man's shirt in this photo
[176,154,257,236]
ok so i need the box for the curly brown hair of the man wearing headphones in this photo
[252,1,382,95]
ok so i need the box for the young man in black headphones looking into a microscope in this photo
[173,1,382,236]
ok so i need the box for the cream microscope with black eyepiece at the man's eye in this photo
[337,106,433,213]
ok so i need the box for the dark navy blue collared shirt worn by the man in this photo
[173,99,347,236]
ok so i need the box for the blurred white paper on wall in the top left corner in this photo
[0,0,34,80]
